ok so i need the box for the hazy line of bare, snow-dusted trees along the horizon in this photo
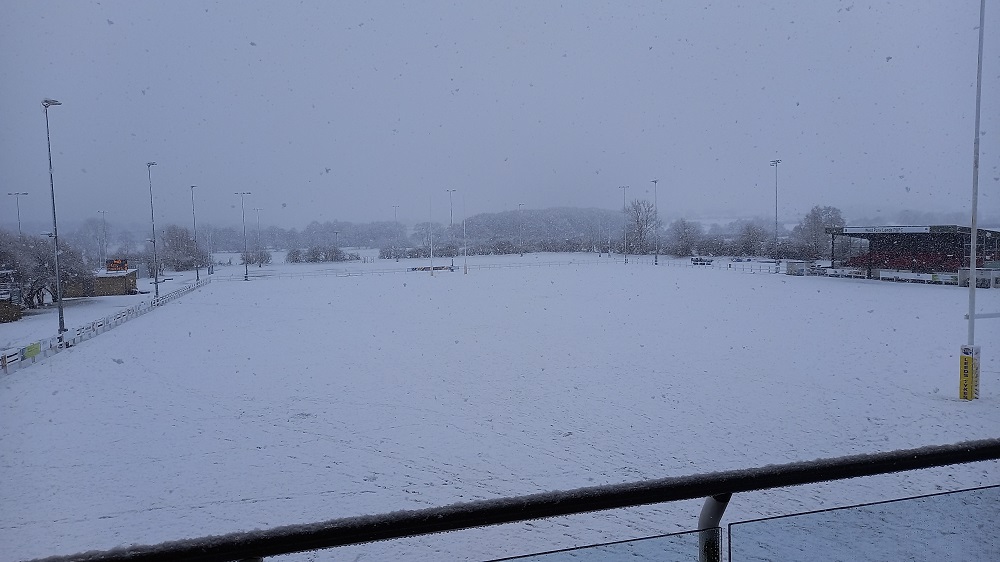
[0,199,846,306]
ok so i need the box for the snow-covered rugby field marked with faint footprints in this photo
[0,256,1000,560]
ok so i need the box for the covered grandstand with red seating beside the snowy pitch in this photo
[826,225,1000,277]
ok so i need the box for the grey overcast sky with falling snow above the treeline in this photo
[0,0,1000,228]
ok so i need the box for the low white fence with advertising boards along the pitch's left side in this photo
[0,277,212,375]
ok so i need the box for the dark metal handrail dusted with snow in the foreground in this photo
[33,439,1000,562]
